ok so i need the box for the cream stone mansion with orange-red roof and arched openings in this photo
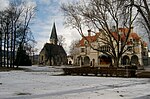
[73,28,148,67]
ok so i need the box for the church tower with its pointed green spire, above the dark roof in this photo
[50,23,58,45]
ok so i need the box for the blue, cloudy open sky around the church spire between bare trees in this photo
[0,0,80,53]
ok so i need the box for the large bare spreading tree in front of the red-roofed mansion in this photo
[61,0,150,66]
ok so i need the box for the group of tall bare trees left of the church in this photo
[0,0,36,67]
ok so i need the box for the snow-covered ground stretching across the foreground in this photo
[0,66,150,99]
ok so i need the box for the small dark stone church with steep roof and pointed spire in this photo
[39,23,67,66]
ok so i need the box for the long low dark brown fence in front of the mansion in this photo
[63,67,136,77]
